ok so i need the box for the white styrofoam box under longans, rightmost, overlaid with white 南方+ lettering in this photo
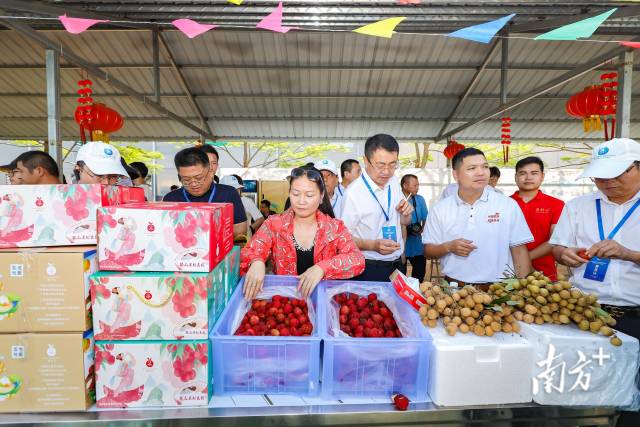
[520,322,639,406]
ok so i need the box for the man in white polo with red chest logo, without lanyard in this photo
[422,148,533,286]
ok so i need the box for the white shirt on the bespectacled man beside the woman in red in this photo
[341,169,404,261]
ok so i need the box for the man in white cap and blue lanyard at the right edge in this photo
[550,138,640,338]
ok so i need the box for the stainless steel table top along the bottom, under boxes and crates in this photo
[0,403,617,427]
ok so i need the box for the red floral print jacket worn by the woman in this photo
[240,209,364,280]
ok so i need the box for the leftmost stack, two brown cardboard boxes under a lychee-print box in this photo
[0,181,144,412]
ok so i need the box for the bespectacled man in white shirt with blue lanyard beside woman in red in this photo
[342,134,413,282]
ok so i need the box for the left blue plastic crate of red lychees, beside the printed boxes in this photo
[210,276,321,396]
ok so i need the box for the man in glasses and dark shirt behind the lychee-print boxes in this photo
[163,147,247,239]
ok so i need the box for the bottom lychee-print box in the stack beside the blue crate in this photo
[95,341,211,408]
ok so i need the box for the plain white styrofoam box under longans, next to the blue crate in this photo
[429,325,534,406]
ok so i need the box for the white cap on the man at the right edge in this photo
[579,138,640,179]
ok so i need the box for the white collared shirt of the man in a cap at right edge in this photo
[549,191,640,306]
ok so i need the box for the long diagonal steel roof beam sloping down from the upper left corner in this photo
[0,16,216,140]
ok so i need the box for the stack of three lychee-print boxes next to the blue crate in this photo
[91,203,238,408]
